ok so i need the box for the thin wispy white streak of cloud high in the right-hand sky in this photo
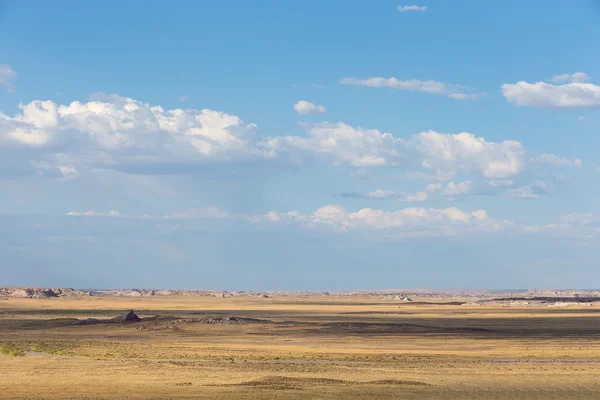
[340,77,481,100]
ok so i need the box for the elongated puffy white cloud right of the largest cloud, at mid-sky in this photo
[273,123,526,178]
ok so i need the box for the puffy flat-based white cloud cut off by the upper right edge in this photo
[502,72,600,108]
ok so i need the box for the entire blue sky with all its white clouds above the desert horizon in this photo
[0,0,600,289]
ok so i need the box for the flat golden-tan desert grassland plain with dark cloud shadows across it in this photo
[0,296,600,400]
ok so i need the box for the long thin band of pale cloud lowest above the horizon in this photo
[66,204,600,239]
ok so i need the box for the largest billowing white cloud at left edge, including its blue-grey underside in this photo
[0,95,272,169]
